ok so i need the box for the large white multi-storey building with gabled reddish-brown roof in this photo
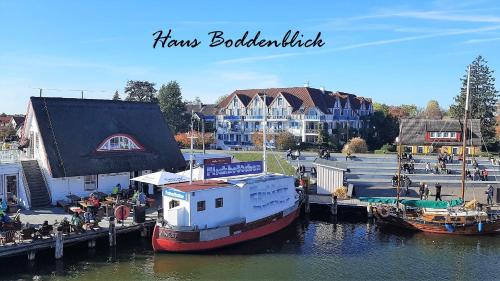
[215,87,373,149]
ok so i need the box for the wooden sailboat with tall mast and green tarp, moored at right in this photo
[360,66,500,235]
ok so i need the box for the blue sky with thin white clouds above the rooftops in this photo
[0,0,500,113]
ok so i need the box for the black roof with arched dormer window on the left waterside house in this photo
[31,97,185,178]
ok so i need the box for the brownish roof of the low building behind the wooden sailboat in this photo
[400,118,481,146]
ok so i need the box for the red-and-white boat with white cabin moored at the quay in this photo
[152,95,301,252]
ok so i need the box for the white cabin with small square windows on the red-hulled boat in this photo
[163,174,298,229]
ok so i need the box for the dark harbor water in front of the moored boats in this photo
[0,211,500,280]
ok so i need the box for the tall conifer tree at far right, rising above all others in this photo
[450,56,499,149]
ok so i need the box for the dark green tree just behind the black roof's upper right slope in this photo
[158,81,191,133]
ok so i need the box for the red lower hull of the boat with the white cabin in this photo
[152,208,300,252]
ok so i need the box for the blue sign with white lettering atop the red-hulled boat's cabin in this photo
[204,161,263,179]
